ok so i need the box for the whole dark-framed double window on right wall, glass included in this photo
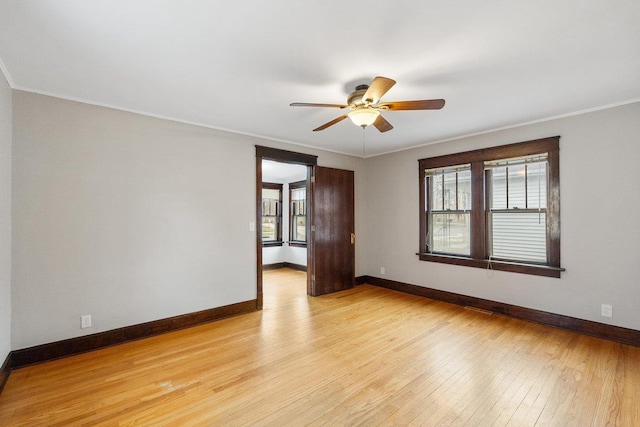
[418,137,563,277]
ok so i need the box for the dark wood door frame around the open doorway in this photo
[256,145,318,310]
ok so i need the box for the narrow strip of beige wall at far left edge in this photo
[0,71,12,365]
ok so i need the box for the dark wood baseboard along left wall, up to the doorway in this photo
[10,300,258,369]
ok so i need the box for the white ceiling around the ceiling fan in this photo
[0,0,640,156]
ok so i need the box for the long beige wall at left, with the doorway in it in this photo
[12,91,364,349]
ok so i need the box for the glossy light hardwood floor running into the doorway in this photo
[0,270,640,426]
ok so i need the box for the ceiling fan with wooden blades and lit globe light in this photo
[289,76,444,132]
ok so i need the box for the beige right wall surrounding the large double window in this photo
[365,103,640,330]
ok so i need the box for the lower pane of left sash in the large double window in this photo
[429,212,471,256]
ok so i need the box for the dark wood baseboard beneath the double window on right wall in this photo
[358,276,640,347]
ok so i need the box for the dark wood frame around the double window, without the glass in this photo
[417,136,564,278]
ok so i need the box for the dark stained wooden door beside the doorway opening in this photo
[308,166,355,296]
